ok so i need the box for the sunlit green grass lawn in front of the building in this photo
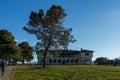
[10,65,120,80]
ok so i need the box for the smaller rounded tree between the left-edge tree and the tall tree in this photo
[18,41,33,64]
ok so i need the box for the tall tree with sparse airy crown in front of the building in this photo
[23,5,76,67]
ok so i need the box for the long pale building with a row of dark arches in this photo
[37,49,94,65]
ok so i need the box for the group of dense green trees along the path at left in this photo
[0,29,33,64]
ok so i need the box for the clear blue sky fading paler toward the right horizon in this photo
[0,0,120,61]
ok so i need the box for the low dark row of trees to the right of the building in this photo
[94,57,120,66]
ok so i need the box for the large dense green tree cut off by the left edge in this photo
[0,29,20,62]
